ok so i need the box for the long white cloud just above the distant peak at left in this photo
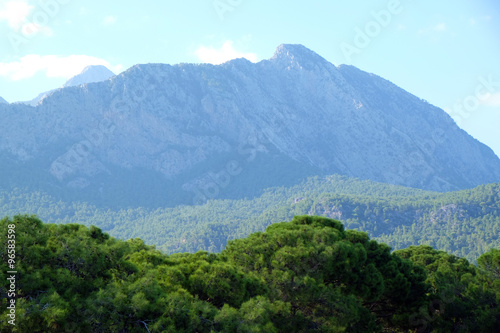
[0,54,122,81]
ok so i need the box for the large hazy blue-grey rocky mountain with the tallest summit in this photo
[0,45,500,207]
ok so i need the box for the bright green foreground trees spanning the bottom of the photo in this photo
[0,216,500,333]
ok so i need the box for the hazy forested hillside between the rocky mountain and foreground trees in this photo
[0,175,500,262]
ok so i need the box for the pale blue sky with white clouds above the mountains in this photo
[0,0,500,156]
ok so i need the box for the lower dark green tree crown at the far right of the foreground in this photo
[395,245,500,332]
